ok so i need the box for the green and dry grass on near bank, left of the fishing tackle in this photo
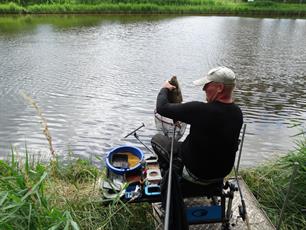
[0,154,154,230]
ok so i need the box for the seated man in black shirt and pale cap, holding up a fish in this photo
[151,66,243,189]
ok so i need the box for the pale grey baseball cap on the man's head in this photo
[193,66,236,87]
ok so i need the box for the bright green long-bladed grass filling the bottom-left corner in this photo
[0,152,78,229]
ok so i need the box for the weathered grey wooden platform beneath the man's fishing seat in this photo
[152,178,275,230]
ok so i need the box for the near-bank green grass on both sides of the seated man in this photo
[0,139,306,230]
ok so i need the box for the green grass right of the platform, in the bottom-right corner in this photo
[242,137,306,230]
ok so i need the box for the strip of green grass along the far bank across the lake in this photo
[0,0,306,17]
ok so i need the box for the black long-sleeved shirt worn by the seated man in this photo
[156,88,243,179]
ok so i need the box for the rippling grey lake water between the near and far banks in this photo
[0,15,306,167]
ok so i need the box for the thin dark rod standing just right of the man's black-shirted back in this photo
[234,124,251,229]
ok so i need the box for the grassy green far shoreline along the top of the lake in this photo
[0,2,306,18]
